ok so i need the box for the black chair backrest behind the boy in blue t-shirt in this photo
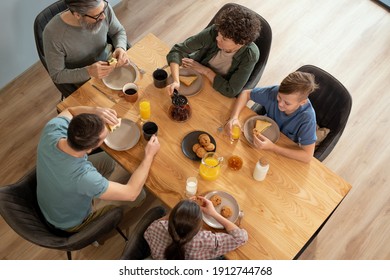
[297,65,352,161]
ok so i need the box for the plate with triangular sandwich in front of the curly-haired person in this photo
[167,68,203,96]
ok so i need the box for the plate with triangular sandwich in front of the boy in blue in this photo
[244,116,280,145]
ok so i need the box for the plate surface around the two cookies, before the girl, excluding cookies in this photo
[203,191,240,229]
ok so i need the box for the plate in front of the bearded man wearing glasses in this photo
[102,62,138,90]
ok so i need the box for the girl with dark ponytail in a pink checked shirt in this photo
[144,196,248,260]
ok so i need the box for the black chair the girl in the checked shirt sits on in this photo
[121,206,167,260]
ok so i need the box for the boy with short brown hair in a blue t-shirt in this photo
[225,71,318,163]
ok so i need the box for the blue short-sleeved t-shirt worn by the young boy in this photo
[250,86,317,146]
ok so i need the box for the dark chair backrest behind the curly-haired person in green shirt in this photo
[207,3,272,89]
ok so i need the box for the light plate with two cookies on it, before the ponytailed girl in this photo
[203,191,240,229]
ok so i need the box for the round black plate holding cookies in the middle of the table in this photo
[181,130,217,161]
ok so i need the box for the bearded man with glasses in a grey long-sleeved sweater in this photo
[43,0,128,97]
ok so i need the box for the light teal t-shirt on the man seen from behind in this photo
[37,117,108,229]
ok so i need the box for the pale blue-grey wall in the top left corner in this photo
[0,0,120,89]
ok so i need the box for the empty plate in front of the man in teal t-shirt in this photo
[104,119,141,151]
